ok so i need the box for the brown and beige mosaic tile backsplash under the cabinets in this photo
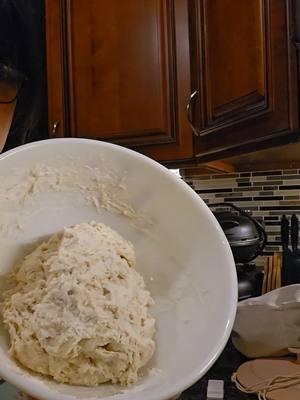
[181,169,300,255]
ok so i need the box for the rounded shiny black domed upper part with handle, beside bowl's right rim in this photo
[209,203,267,264]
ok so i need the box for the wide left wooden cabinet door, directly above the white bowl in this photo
[46,0,193,159]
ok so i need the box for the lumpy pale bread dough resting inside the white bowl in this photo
[3,222,155,386]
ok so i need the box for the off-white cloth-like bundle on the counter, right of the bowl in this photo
[232,284,300,358]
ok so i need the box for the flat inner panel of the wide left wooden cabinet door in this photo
[68,0,174,142]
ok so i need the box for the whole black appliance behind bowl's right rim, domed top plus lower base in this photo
[210,203,267,300]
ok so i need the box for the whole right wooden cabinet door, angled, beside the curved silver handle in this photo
[190,0,298,160]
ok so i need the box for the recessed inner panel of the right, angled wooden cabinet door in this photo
[202,0,267,126]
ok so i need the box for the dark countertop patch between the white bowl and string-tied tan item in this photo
[179,341,257,400]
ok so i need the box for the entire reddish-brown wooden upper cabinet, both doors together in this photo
[46,0,299,165]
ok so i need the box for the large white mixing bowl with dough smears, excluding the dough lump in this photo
[0,139,237,400]
